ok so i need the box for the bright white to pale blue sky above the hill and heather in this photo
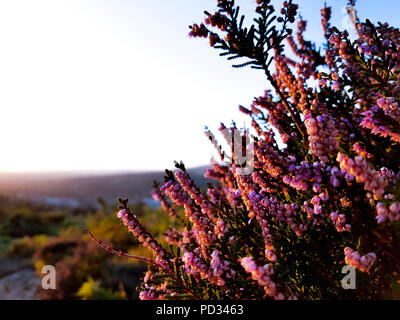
[0,0,400,172]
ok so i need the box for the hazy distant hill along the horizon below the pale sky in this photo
[0,166,211,207]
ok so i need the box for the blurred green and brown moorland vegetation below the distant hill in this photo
[0,197,177,299]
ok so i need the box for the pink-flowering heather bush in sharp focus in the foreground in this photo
[92,0,400,299]
